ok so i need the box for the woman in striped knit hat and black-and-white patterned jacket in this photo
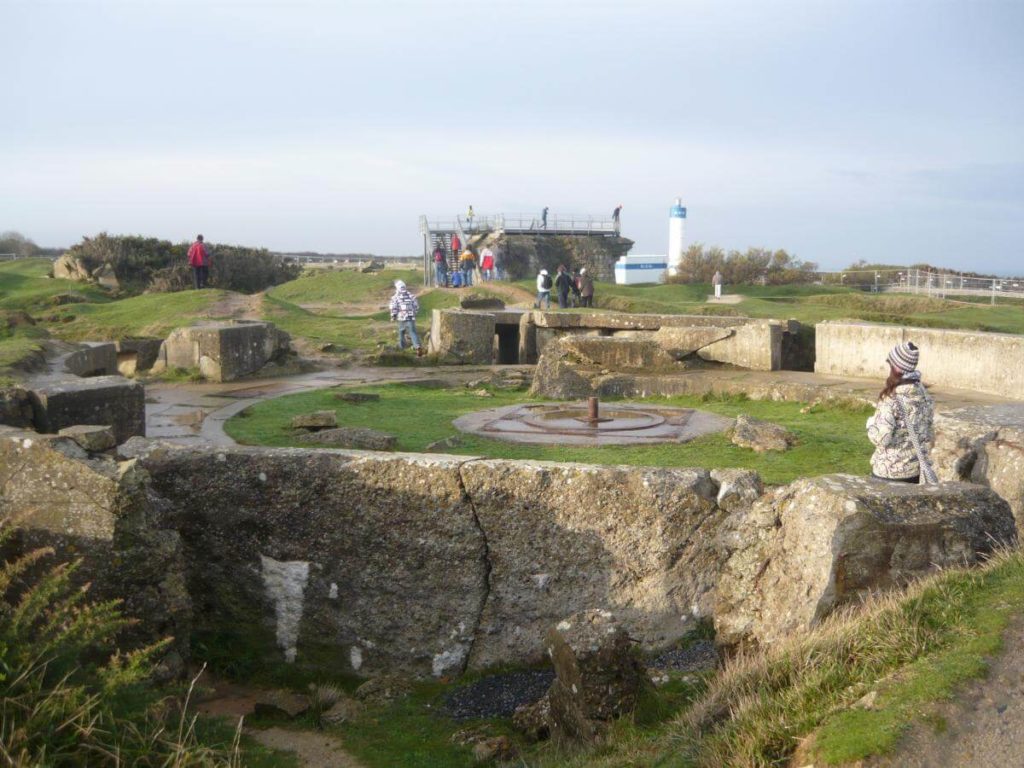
[867,341,937,483]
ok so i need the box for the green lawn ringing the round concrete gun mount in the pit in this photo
[225,384,871,483]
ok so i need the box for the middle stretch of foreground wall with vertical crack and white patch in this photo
[130,443,737,675]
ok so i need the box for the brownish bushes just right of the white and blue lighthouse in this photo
[669,243,818,286]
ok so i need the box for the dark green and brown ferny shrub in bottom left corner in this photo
[0,522,289,768]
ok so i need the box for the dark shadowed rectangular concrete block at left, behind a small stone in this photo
[30,374,145,443]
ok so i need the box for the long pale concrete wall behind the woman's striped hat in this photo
[814,322,1024,399]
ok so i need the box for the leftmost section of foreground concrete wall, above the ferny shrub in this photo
[0,427,191,674]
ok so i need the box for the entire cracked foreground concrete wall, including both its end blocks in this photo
[0,429,1016,676]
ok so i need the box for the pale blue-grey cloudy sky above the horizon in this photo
[0,0,1024,273]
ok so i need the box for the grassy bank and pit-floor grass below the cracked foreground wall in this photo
[190,550,1024,768]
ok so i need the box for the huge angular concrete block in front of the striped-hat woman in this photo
[715,475,1017,646]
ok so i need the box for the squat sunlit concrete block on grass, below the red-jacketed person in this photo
[153,322,290,381]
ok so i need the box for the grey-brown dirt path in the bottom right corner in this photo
[867,616,1024,768]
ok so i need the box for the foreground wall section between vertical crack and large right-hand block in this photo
[461,460,725,669]
